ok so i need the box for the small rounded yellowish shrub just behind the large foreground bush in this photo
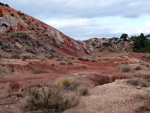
[55,78,71,88]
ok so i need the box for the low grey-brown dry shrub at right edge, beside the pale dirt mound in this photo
[127,78,150,87]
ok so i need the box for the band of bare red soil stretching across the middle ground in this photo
[0,57,128,90]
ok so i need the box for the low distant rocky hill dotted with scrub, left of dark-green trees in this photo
[82,38,133,54]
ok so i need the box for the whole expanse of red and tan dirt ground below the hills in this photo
[0,54,150,113]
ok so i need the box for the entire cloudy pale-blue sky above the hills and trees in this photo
[0,0,150,40]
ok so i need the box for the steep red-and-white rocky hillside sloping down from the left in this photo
[0,3,87,58]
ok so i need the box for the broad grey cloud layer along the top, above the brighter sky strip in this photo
[1,0,150,19]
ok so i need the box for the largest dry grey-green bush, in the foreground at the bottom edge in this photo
[24,87,78,113]
